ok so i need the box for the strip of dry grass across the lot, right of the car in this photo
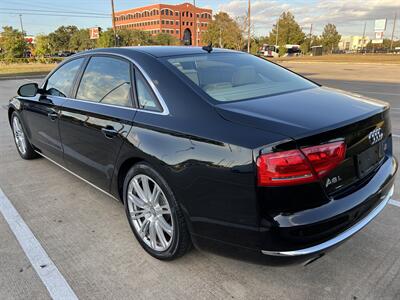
[271,54,400,64]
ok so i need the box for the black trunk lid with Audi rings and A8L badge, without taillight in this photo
[216,88,391,195]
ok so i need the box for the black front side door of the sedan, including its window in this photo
[23,58,84,163]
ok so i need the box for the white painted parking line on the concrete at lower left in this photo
[0,188,78,300]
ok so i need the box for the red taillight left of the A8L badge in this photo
[257,142,346,186]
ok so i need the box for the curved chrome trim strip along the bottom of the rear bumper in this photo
[261,186,394,257]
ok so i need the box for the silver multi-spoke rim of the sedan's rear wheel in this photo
[128,174,174,251]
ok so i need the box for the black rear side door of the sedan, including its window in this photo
[59,55,136,191]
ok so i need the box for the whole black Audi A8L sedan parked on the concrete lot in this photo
[8,47,397,261]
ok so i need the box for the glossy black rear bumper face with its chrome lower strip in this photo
[261,156,397,258]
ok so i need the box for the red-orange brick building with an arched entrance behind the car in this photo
[115,3,212,46]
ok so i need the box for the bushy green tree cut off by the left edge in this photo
[0,26,28,60]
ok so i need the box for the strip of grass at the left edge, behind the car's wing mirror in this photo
[0,63,57,77]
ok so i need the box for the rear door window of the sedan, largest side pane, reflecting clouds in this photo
[76,56,132,107]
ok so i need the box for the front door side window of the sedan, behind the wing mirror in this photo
[46,58,84,97]
